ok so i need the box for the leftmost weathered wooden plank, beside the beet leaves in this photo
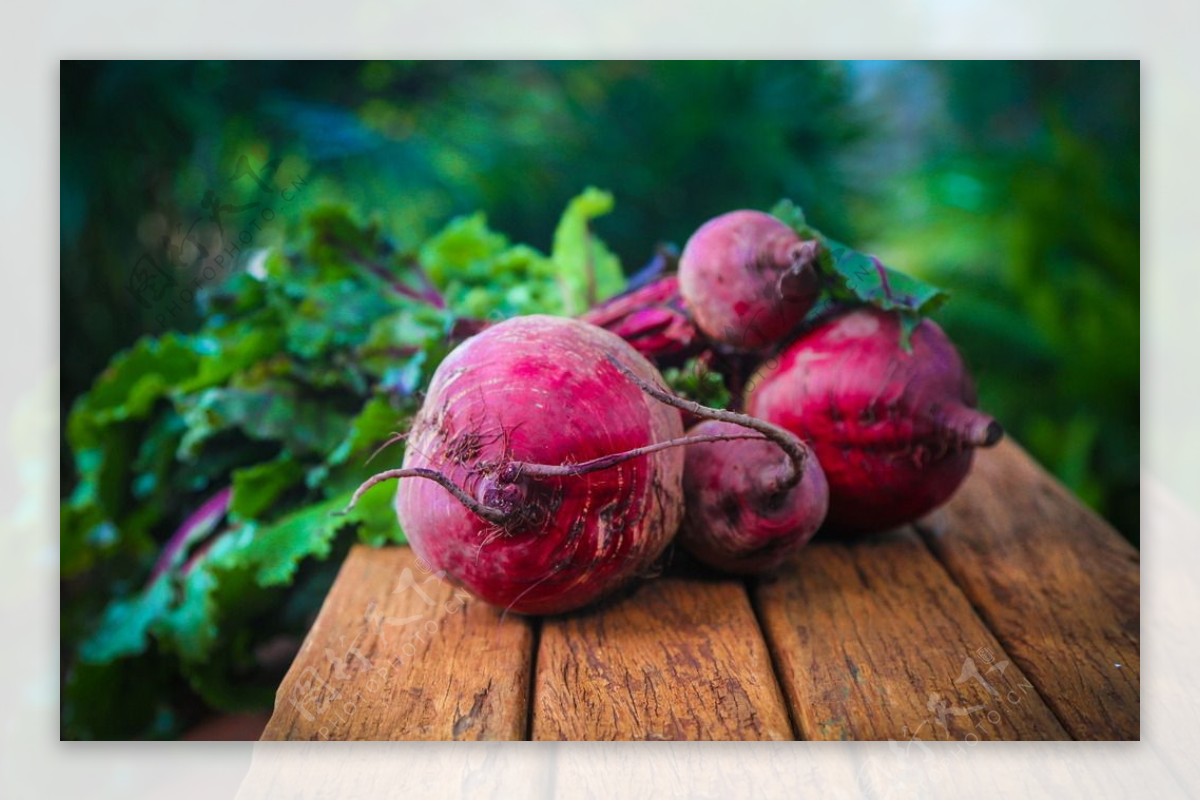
[262,546,533,740]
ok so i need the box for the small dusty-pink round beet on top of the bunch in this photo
[679,211,820,350]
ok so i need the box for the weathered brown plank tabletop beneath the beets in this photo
[263,442,1140,741]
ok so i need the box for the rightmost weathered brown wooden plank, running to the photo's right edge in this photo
[918,442,1140,740]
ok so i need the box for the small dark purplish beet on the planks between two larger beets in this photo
[679,421,829,573]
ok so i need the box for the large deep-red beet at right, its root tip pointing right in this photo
[746,308,1002,531]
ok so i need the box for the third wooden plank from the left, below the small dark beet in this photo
[754,529,1068,741]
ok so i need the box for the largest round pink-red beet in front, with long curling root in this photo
[394,315,684,614]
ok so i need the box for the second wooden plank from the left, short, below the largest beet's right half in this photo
[533,577,792,740]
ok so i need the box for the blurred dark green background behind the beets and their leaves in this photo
[60,61,1140,738]
